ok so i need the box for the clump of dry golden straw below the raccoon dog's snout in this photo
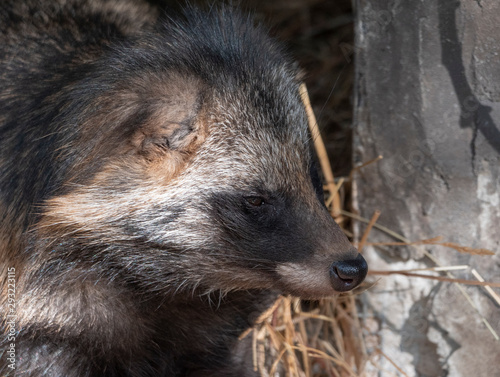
[253,295,368,377]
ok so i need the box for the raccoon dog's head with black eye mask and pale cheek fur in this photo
[41,5,367,298]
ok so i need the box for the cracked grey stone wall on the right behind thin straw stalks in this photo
[353,0,500,377]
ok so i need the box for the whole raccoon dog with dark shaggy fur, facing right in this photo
[0,0,367,377]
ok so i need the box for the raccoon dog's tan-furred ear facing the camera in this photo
[131,75,206,161]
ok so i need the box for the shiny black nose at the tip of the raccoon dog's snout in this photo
[330,254,368,292]
